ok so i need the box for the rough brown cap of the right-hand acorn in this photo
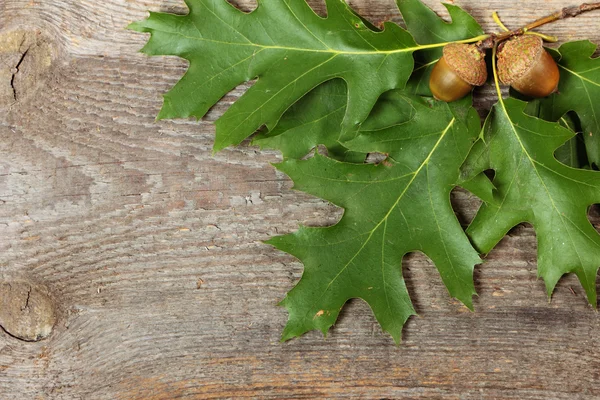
[498,35,544,85]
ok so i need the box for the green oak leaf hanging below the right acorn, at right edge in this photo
[463,98,600,306]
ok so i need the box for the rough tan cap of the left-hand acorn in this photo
[444,43,487,86]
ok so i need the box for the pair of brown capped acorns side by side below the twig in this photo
[429,35,560,102]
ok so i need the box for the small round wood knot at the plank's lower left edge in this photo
[0,281,56,342]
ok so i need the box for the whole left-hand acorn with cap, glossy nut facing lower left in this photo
[429,43,487,102]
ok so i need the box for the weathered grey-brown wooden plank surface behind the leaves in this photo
[0,0,600,400]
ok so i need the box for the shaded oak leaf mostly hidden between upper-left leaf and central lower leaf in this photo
[252,79,414,163]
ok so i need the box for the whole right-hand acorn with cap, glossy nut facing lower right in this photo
[497,35,560,97]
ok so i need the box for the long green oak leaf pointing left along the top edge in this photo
[129,0,424,151]
